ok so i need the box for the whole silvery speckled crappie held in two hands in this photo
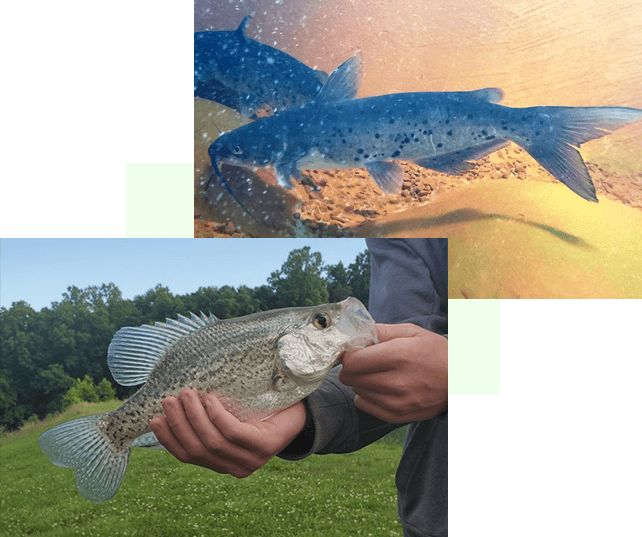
[38,297,377,503]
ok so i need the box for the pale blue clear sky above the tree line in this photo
[0,239,366,310]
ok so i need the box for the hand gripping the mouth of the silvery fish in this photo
[339,324,448,423]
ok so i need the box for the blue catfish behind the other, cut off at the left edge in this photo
[194,15,328,117]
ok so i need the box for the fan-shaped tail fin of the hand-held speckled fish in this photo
[38,414,129,503]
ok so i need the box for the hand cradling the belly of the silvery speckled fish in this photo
[150,388,306,478]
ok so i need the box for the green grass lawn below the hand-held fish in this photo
[0,401,403,537]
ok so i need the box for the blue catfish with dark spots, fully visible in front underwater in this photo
[209,55,642,201]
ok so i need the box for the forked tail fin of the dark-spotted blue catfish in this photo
[516,106,642,201]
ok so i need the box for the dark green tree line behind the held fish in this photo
[0,246,370,430]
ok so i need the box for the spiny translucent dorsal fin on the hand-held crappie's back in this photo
[107,312,218,386]
